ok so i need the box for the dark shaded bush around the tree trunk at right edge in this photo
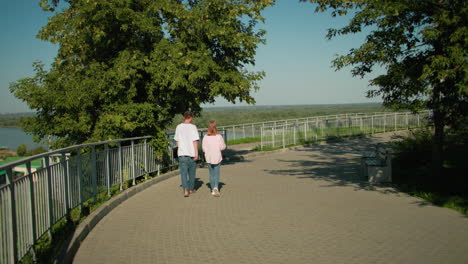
[392,129,468,214]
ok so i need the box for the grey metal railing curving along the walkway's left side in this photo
[0,137,176,264]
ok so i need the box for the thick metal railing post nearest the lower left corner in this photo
[6,168,18,263]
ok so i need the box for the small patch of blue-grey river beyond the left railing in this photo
[0,127,40,151]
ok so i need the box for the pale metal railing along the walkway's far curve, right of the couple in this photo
[260,111,429,149]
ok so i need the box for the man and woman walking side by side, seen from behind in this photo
[174,112,226,197]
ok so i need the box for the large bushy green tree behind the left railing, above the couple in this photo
[10,0,273,153]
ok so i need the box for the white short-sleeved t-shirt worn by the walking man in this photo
[174,123,200,157]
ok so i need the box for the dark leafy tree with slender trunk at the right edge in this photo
[301,0,468,175]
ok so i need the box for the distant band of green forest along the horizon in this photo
[0,103,390,128]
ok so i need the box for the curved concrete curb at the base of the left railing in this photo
[51,170,180,264]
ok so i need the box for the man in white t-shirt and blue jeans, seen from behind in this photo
[174,112,200,197]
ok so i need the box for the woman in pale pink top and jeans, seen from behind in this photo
[202,121,226,197]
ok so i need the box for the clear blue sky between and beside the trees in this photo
[0,0,380,113]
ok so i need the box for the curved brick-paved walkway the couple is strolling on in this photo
[74,134,468,264]
